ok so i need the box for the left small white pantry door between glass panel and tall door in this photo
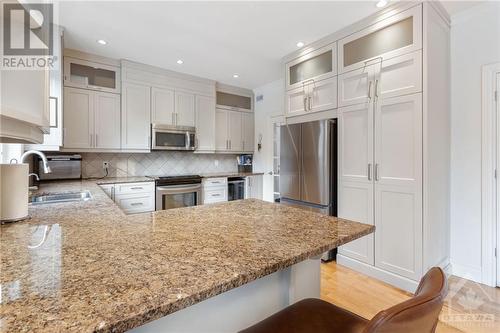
[338,65,377,107]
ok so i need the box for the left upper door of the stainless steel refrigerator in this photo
[280,124,302,200]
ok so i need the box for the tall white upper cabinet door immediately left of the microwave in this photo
[122,82,151,150]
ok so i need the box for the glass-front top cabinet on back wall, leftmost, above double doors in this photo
[64,51,120,93]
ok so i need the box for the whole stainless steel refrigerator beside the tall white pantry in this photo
[280,120,337,216]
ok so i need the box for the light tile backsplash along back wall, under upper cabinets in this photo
[81,151,238,178]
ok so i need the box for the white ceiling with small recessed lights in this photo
[56,0,482,88]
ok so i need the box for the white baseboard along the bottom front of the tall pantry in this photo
[337,254,418,293]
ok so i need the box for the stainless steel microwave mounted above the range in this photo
[151,124,196,150]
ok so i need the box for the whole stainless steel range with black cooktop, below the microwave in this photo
[151,175,201,210]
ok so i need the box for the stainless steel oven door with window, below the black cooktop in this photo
[156,184,201,210]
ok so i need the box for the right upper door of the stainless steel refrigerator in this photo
[300,120,330,206]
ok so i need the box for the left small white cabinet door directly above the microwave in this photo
[151,87,175,125]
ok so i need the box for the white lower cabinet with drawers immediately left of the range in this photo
[100,182,155,214]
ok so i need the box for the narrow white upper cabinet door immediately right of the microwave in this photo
[196,95,215,151]
